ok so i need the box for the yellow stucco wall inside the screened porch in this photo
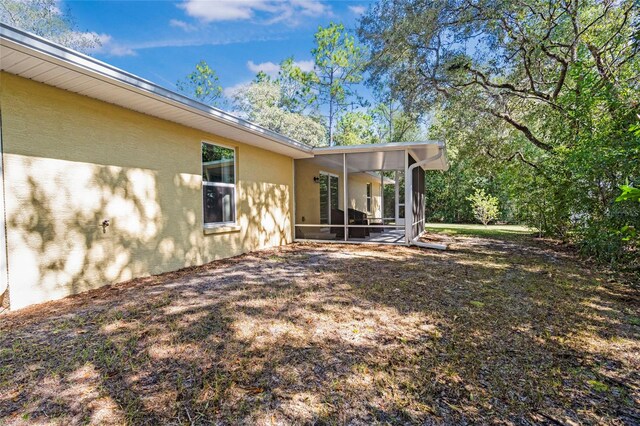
[295,159,381,225]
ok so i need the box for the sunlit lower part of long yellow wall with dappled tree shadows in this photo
[7,157,291,306]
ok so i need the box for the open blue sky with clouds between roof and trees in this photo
[63,0,369,98]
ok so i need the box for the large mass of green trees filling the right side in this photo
[359,0,640,265]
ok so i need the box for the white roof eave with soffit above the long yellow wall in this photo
[0,23,313,158]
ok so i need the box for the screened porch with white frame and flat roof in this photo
[294,141,448,244]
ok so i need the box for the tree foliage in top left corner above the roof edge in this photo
[0,0,101,52]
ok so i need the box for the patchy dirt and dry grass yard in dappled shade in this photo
[0,235,640,425]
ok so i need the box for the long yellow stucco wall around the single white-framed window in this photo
[0,73,293,309]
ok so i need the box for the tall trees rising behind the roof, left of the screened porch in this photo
[239,27,384,146]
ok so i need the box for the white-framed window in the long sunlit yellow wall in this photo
[202,142,236,227]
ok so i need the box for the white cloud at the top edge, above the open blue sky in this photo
[179,0,331,25]
